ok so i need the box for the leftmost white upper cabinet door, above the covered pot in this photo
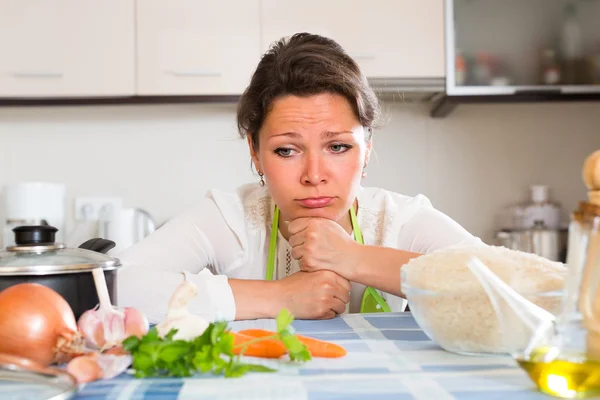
[0,0,135,98]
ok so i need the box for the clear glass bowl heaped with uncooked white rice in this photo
[402,244,567,354]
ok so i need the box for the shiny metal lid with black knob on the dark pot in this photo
[0,225,120,276]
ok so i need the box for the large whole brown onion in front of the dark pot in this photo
[0,283,80,366]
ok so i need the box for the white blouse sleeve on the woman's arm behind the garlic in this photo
[117,197,243,323]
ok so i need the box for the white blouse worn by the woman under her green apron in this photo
[117,184,480,323]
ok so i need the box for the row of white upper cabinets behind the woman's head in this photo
[0,0,445,101]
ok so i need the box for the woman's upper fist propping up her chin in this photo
[288,218,360,280]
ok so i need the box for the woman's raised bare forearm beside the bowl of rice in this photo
[349,245,421,297]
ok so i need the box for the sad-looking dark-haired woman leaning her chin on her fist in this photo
[118,33,479,322]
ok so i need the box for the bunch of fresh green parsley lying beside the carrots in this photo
[123,309,311,378]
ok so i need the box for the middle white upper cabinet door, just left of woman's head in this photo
[137,0,260,95]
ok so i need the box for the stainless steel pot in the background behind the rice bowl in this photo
[496,222,569,263]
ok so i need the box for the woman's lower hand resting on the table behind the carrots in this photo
[276,271,352,319]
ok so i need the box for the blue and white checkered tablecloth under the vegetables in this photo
[3,313,550,400]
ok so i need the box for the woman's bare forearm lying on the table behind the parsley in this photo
[229,279,281,320]
